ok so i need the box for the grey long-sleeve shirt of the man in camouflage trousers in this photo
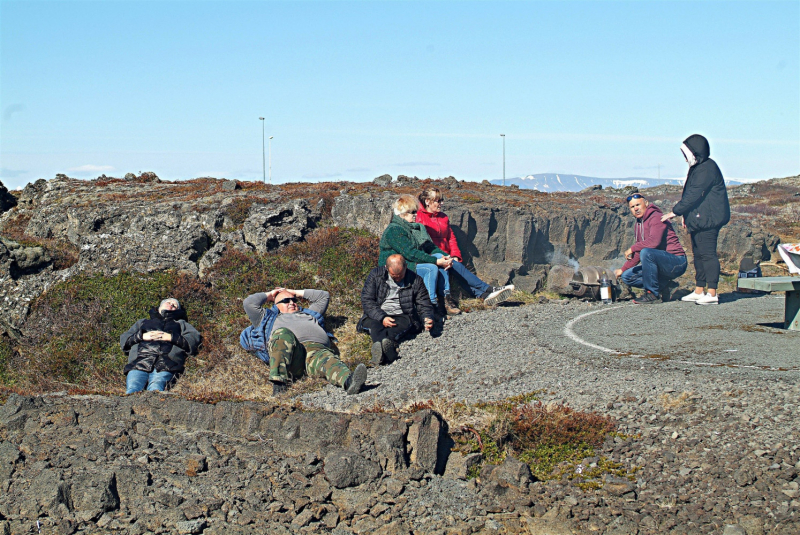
[244,290,331,346]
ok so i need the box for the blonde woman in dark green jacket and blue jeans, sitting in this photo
[378,195,453,306]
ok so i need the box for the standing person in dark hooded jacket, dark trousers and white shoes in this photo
[661,134,731,305]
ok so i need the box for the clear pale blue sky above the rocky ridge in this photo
[0,0,800,191]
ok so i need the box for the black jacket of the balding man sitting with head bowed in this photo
[358,266,433,331]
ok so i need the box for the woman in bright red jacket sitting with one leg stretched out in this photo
[417,187,514,315]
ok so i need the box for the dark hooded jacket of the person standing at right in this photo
[672,134,731,232]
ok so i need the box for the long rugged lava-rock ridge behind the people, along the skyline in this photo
[0,173,778,331]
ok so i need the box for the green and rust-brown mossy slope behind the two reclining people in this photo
[0,227,378,401]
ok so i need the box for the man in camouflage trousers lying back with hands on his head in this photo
[239,288,367,395]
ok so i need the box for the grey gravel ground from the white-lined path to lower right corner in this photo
[300,294,800,534]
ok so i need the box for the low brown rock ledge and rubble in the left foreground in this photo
[0,393,468,534]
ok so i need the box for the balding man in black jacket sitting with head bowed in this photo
[357,254,433,366]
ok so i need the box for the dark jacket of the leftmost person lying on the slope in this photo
[120,308,200,374]
